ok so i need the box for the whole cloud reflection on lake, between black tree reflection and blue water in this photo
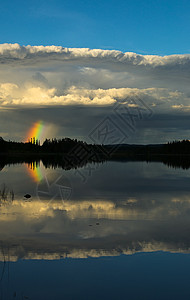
[0,162,190,261]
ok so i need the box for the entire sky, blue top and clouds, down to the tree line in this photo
[0,0,190,143]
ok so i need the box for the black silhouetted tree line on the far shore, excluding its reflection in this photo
[0,137,190,156]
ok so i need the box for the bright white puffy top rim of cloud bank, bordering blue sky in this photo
[0,44,190,66]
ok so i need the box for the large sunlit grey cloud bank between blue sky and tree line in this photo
[0,44,190,142]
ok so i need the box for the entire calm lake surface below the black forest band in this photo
[0,162,190,300]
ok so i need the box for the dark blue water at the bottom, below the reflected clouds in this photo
[1,252,190,300]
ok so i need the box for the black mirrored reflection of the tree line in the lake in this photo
[0,152,190,178]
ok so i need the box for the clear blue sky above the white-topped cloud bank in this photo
[0,0,190,55]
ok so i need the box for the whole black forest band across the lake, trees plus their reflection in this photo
[0,137,190,170]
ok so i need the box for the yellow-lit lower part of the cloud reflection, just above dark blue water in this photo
[0,191,190,261]
